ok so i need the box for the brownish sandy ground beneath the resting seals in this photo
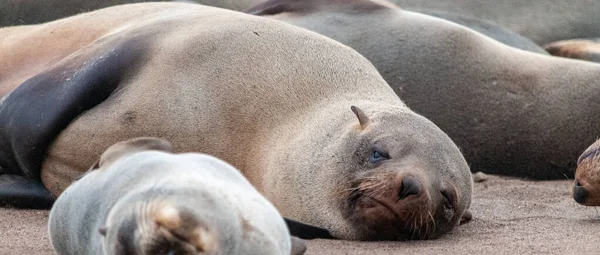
[0,176,600,254]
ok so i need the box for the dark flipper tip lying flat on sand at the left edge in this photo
[0,174,54,209]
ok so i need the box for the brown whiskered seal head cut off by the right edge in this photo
[572,140,600,206]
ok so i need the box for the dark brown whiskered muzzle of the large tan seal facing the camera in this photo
[346,176,439,240]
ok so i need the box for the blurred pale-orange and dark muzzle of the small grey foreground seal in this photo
[154,205,217,253]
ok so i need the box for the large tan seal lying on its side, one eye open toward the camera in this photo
[0,3,473,240]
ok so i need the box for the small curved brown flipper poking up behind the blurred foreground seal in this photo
[96,137,173,169]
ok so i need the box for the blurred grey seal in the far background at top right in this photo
[391,0,600,45]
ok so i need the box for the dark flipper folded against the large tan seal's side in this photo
[0,36,143,207]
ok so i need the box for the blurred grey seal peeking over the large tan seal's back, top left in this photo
[0,0,262,27]
